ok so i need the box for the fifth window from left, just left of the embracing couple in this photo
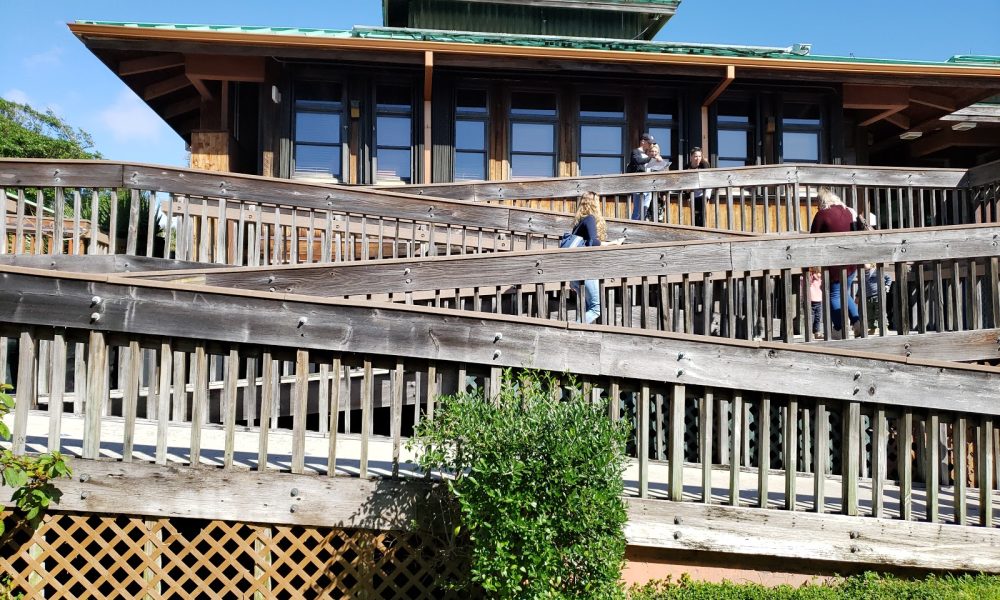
[580,96,625,175]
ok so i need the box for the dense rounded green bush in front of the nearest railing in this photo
[412,372,629,599]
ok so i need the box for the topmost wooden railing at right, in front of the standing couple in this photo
[392,163,1000,233]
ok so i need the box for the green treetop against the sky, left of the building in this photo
[0,98,101,158]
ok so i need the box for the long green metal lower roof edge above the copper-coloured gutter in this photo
[77,20,1000,67]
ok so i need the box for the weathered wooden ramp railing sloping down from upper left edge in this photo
[0,159,729,265]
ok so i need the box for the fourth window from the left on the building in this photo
[510,92,556,178]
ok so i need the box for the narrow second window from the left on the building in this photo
[375,85,413,183]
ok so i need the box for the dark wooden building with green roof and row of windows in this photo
[70,0,1000,184]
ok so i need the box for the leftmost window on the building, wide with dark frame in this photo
[292,81,343,180]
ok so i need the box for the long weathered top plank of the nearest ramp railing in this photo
[0,267,1000,414]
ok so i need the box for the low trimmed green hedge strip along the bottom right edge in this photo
[629,573,1000,600]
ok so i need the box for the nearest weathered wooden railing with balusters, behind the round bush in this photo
[0,267,1000,536]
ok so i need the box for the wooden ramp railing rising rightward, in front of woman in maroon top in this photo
[137,225,1000,361]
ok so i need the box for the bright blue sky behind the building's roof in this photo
[0,0,1000,165]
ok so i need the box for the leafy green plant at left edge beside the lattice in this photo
[0,385,72,535]
